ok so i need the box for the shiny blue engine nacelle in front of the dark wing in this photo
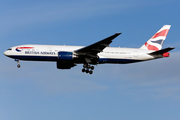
[58,51,74,61]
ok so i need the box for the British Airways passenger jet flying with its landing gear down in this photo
[4,25,174,74]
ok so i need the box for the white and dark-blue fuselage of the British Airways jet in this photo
[4,45,159,64]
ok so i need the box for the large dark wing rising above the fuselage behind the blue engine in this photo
[75,33,121,57]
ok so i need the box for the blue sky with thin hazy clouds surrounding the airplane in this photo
[0,0,180,120]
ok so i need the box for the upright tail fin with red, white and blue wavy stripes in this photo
[140,25,171,51]
